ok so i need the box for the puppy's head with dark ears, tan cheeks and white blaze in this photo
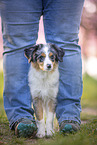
[25,43,64,71]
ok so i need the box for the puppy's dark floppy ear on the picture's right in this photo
[50,44,65,62]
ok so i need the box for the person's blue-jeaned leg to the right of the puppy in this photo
[43,0,84,130]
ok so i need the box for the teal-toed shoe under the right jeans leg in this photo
[60,121,80,133]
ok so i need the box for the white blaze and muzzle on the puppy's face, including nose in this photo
[43,46,53,70]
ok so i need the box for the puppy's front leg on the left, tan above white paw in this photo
[33,97,45,138]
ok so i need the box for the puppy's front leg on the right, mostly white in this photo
[46,99,55,136]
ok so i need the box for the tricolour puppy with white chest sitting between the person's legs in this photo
[25,43,64,138]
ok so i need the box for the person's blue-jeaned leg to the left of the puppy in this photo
[1,0,42,133]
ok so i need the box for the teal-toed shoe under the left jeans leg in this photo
[15,118,37,138]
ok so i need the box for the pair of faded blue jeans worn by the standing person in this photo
[1,0,84,128]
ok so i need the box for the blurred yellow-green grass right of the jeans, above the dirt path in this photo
[81,74,97,109]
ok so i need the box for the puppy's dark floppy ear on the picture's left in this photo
[24,44,42,63]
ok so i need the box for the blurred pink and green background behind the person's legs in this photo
[0,0,97,121]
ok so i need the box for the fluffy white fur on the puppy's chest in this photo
[28,65,59,101]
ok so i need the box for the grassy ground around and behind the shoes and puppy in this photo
[0,72,97,145]
